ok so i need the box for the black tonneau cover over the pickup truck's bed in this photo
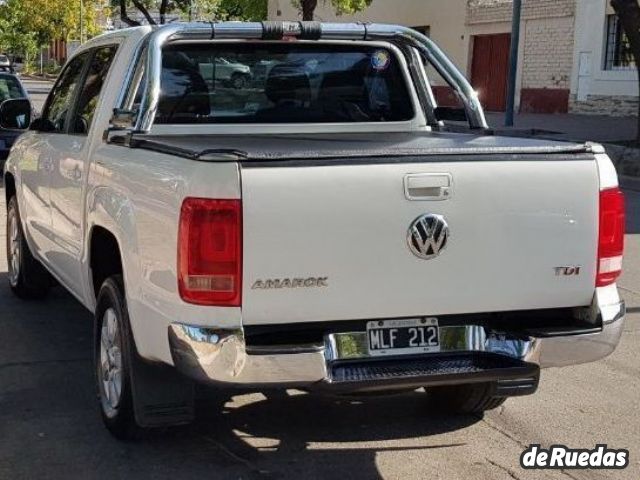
[110,132,591,164]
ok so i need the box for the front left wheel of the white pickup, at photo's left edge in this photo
[7,195,52,300]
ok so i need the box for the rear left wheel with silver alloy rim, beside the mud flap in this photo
[94,275,142,440]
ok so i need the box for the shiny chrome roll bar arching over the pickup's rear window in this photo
[124,22,487,133]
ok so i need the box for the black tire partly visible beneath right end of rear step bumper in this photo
[427,383,507,414]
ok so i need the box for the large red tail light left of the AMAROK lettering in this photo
[178,198,242,307]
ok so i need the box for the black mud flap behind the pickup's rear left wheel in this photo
[131,354,195,428]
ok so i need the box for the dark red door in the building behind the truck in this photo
[471,33,511,112]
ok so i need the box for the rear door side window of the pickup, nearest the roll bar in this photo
[69,45,117,135]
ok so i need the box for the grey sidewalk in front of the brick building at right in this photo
[487,113,640,177]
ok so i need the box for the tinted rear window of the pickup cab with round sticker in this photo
[155,43,414,124]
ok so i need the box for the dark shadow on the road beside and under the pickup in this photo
[0,272,478,478]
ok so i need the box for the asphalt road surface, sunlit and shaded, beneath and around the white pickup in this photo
[0,78,640,480]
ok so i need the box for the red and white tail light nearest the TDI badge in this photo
[596,188,624,287]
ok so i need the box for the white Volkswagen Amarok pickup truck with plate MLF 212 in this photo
[0,22,625,437]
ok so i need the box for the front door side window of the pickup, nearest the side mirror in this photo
[42,52,89,133]
